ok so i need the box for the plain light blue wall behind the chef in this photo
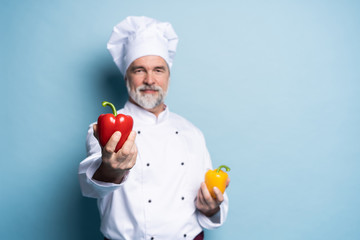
[0,0,360,240]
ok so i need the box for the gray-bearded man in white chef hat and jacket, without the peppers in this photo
[79,17,229,240]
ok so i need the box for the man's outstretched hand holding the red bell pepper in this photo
[93,124,137,183]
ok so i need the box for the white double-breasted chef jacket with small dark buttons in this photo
[79,102,228,240]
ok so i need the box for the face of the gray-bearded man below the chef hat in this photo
[125,56,170,110]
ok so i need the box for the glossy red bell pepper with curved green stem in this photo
[97,101,134,152]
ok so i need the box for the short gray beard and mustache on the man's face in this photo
[126,80,167,109]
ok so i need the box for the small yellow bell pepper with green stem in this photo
[205,165,230,198]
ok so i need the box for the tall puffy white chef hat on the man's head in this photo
[107,16,178,76]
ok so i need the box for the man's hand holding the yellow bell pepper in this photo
[196,178,230,217]
